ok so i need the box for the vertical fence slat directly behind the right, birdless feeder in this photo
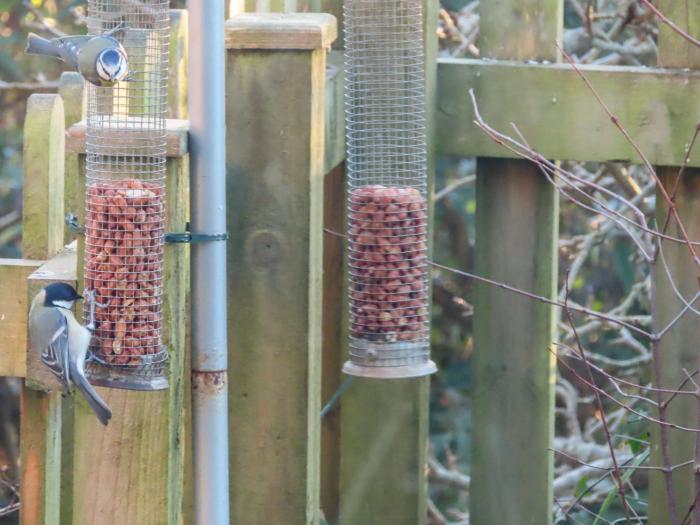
[338,0,438,525]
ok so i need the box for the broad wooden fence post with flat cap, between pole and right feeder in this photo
[226,14,336,524]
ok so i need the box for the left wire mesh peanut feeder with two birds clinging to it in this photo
[83,0,169,390]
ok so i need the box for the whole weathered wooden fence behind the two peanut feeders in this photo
[0,0,700,525]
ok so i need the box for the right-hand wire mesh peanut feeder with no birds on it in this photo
[343,0,437,378]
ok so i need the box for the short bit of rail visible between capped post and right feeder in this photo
[323,51,345,173]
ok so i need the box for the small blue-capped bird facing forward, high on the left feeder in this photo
[26,25,129,87]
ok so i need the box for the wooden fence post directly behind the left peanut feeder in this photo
[72,12,189,525]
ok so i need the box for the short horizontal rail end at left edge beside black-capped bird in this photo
[0,259,42,377]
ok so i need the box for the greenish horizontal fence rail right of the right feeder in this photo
[436,59,700,166]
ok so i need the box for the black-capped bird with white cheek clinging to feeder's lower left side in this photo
[29,283,112,425]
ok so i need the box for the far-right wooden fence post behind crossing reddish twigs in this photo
[649,0,700,525]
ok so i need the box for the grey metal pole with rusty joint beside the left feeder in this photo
[188,0,229,525]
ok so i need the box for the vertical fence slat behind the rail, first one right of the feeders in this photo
[470,0,563,525]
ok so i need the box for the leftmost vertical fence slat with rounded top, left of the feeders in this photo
[20,94,65,525]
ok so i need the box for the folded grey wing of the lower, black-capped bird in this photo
[31,308,70,389]
